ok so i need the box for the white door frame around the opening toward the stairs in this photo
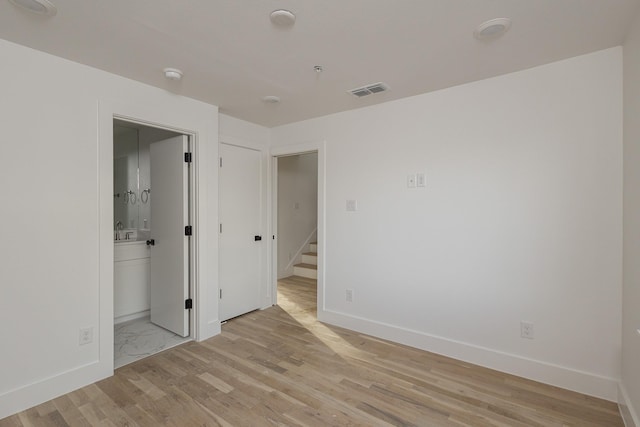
[267,141,327,320]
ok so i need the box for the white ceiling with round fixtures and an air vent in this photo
[0,0,640,127]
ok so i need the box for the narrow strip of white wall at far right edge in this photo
[621,11,640,427]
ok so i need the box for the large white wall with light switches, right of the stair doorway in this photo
[271,48,622,400]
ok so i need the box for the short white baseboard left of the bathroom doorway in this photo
[0,360,113,419]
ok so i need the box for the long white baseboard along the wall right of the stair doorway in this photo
[318,310,620,402]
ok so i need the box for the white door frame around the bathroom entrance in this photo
[94,100,214,380]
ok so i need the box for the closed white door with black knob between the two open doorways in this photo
[219,144,266,320]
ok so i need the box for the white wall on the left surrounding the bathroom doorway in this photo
[0,40,219,418]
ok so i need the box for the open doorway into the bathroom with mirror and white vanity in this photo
[113,119,193,368]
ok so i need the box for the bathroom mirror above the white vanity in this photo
[113,124,141,230]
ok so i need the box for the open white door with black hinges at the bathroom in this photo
[149,135,189,337]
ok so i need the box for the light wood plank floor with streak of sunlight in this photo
[0,277,623,427]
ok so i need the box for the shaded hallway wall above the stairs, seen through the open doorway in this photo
[277,153,318,278]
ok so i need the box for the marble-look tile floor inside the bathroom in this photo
[113,317,191,369]
